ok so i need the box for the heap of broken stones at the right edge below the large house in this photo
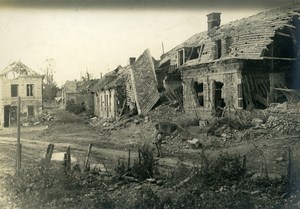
[264,116,300,135]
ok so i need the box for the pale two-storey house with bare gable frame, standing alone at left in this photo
[0,62,43,127]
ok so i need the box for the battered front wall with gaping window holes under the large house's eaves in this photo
[182,61,243,118]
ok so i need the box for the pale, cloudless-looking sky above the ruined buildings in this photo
[0,0,292,85]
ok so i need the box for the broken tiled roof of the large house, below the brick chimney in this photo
[160,4,300,66]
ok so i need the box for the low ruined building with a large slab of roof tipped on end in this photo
[92,50,160,120]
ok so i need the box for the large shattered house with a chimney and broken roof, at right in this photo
[160,5,300,116]
